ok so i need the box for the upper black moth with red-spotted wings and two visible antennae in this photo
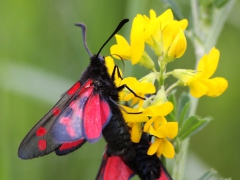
[18,19,138,160]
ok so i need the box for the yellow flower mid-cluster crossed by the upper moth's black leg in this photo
[120,77,156,107]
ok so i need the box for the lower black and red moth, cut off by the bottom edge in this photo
[96,133,172,180]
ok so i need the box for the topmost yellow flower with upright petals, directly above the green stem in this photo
[144,9,188,62]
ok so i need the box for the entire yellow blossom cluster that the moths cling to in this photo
[106,9,228,158]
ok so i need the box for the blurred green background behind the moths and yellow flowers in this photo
[0,0,240,180]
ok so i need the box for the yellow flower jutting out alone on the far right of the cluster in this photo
[173,47,228,98]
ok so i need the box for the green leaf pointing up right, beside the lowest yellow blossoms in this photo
[178,116,212,141]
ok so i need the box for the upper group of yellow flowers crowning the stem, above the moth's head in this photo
[110,9,188,70]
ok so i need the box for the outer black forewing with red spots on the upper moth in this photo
[18,81,80,159]
